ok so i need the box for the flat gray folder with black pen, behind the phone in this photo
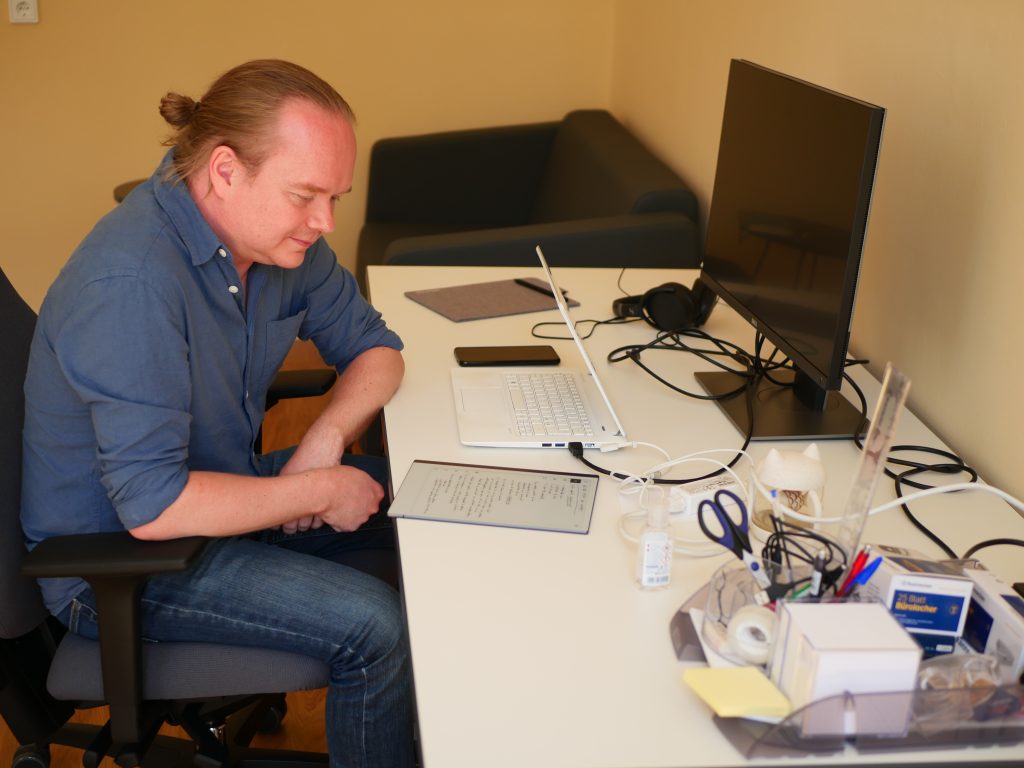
[406,278,580,323]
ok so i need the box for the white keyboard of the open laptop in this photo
[505,372,593,436]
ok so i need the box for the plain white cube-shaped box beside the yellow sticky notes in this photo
[770,601,922,735]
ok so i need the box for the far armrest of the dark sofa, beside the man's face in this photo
[367,123,558,229]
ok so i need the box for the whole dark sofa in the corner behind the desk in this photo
[356,110,700,294]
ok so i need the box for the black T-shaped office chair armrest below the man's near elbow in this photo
[22,531,209,752]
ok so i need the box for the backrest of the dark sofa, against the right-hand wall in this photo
[530,110,696,223]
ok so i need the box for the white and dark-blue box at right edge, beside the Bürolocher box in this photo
[964,568,1024,684]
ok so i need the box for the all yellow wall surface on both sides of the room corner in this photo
[0,0,1024,505]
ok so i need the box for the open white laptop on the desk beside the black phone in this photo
[452,246,626,449]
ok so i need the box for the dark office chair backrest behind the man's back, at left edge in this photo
[0,270,47,638]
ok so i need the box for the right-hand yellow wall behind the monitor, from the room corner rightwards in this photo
[611,0,1024,505]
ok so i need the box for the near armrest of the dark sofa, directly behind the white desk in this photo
[385,213,700,268]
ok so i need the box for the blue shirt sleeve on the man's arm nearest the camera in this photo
[51,273,191,528]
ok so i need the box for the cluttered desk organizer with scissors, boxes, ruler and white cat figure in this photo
[671,367,1024,758]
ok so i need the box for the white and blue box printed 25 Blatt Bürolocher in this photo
[861,548,974,654]
